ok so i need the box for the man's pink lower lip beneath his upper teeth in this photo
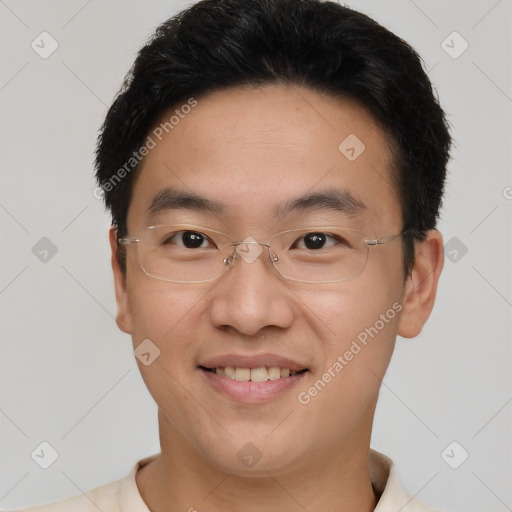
[199,369,308,404]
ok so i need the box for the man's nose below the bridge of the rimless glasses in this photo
[210,237,293,336]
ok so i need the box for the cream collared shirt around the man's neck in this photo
[12,450,444,512]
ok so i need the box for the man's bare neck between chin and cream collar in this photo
[136,413,377,512]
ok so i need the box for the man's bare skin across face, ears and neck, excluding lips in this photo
[110,85,443,512]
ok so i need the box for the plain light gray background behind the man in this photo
[0,0,512,512]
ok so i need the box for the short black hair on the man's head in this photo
[96,0,451,277]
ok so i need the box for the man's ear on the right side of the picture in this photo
[398,229,444,338]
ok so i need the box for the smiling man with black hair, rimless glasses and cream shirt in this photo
[14,0,450,512]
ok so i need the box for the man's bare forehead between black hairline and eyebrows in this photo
[128,85,401,229]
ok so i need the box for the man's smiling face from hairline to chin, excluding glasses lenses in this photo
[112,86,438,474]
